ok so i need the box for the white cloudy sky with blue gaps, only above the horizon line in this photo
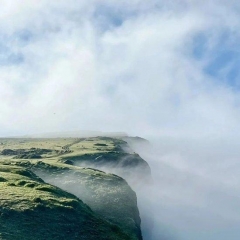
[0,0,239,137]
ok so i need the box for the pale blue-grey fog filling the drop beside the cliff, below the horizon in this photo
[128,138,240,240]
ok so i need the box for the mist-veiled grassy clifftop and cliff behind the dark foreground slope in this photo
[0,137,150,239]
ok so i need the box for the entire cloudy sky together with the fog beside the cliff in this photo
[0,0,240,240]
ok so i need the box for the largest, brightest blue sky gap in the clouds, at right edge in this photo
[193,30,240,90]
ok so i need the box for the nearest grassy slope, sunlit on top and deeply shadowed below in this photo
[0,165,133,240]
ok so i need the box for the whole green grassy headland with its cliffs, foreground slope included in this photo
[0,137,150,240]
